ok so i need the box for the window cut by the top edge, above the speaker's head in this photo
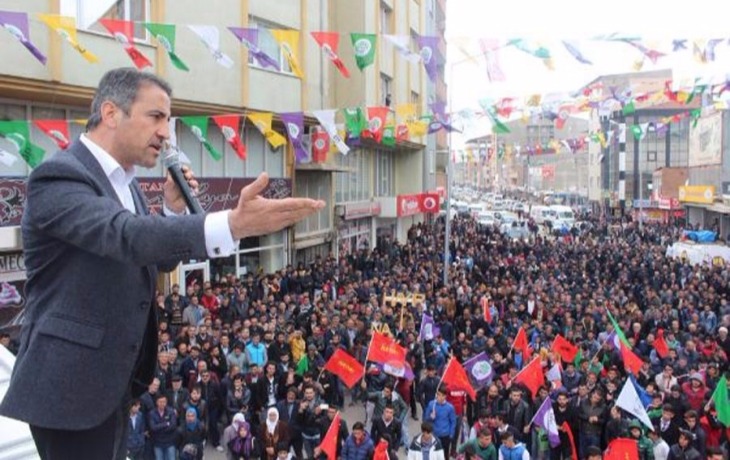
[61,0,150,40]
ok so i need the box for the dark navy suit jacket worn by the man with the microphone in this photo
[0,140,207,430]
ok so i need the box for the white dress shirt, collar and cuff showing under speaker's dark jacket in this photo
[80,134,238,258]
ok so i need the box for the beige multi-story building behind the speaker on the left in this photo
[0,0,445,292]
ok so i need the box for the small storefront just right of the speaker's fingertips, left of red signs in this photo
[335,201,381,257]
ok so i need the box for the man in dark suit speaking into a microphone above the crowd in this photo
[0,68,324,460]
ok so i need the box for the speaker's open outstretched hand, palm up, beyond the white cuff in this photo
[228,172,325,240]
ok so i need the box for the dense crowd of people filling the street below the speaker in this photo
[7,210,730,460]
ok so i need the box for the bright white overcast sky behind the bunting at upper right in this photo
[446,0,730,147]
